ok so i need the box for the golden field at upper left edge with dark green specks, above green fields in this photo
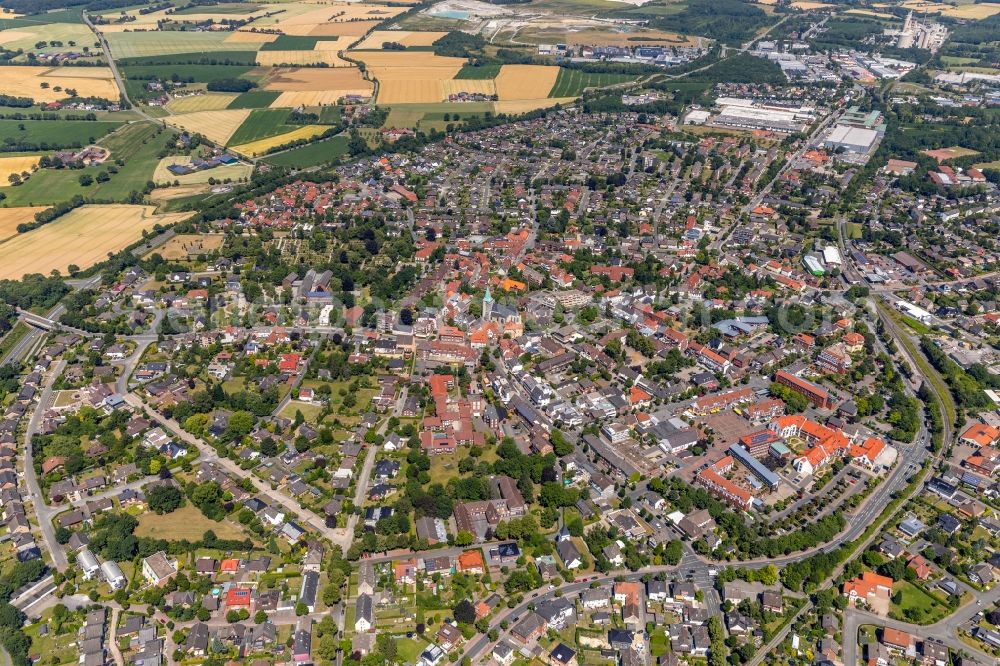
[0,66,119,102]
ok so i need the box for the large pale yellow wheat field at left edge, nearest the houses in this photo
[0,204,191,279]
